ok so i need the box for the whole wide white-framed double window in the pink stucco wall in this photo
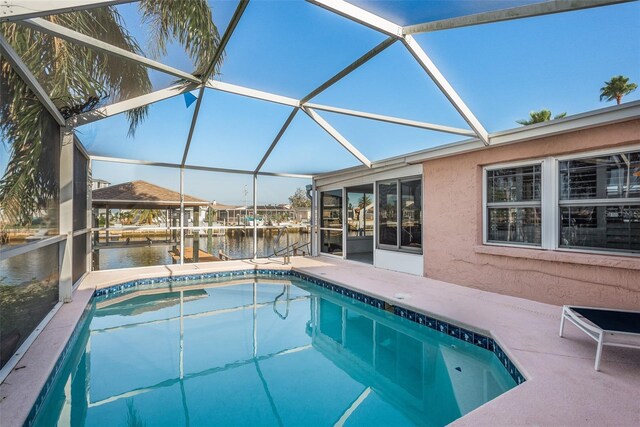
[483,147,640,254]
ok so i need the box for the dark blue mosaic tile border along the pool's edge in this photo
[24,269,526,427]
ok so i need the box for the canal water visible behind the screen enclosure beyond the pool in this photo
[94,232,311,270]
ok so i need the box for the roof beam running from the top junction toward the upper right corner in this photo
[402,0,636,34]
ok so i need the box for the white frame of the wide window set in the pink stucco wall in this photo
[482,144,640,258]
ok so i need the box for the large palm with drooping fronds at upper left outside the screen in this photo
[0,0,220,224]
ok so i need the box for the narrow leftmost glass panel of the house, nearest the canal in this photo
[320,190,342,256]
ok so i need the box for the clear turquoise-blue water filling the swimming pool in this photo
[35,277,515,426]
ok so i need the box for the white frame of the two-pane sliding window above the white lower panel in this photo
[374,175,424,255]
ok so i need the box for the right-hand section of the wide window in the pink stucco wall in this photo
[558,151,640,252]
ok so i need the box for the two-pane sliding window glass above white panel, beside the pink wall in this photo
[378,178,422,252]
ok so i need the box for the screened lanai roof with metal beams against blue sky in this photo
[0,0,640,177]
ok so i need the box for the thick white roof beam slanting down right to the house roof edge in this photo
[402,35,489,145]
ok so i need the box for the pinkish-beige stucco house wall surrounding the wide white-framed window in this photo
[423,119,640,309]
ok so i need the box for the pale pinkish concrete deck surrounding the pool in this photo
[0,257,640,427]
